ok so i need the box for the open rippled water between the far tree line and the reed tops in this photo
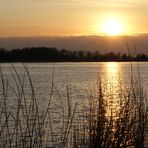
[1,62,148,96]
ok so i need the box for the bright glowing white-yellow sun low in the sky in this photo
[102,18,123,36]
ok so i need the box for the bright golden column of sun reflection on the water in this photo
[105,62,121,116]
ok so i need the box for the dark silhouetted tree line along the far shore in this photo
[0,47,148,62]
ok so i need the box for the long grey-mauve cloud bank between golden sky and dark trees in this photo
[0,34,148,54]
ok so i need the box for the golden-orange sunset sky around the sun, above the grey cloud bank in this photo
[0,0,148,37]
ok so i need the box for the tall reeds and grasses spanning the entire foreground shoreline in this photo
[0,65,148,148]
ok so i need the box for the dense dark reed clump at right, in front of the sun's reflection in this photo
[71,71,148,148]
